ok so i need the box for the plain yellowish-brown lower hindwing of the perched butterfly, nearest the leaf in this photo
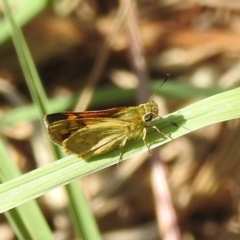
[62,118,129,159]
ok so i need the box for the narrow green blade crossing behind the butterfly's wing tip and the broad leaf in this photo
[0,0,101,240]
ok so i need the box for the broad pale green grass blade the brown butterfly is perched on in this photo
[0,88,240,212]
